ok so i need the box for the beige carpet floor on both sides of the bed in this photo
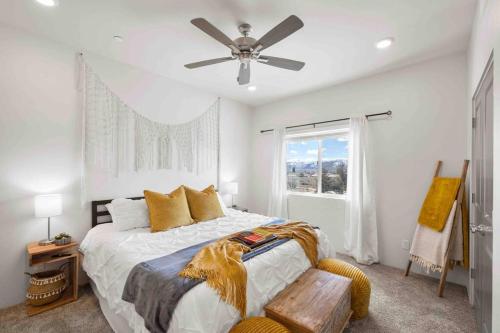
[0,258,476,333]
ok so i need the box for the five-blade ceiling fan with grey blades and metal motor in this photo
[184,15,305,85]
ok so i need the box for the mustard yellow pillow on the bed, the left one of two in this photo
[144,186,193,232]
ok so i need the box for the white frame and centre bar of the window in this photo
[285,127,349,200]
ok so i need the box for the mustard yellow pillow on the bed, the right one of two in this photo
[184,185,224,222]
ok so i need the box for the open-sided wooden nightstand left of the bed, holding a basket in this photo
[26,242,80,316]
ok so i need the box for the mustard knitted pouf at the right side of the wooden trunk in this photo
[318,258,371,320]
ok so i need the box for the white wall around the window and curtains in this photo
[250,50,468,284]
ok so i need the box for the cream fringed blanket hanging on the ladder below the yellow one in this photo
[410,200,463,272]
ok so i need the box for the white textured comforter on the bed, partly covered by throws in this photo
[80,209,335,333]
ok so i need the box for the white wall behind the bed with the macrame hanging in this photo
[0,26,251,308]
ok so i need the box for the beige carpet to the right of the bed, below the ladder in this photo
[341,256,477,333]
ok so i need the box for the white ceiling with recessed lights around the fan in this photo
[0,0,476,105]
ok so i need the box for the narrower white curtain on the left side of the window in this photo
[267,128,288,218]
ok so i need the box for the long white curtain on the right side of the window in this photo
[344,117,378,265]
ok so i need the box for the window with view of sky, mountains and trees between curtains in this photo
[287,131,348,195]
